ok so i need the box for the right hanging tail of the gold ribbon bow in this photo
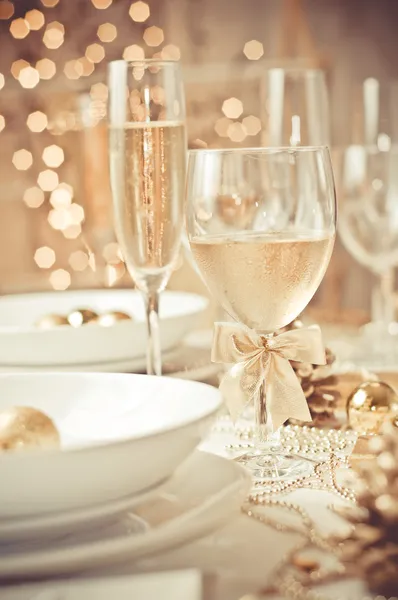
[266,354,312,431]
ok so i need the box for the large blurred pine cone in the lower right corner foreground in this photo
[339,423,398,598]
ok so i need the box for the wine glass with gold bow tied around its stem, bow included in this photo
[187,147,336,479]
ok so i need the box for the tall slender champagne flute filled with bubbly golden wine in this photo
[109,59,186,375]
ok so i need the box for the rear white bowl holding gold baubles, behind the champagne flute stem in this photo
[0,290,208,367]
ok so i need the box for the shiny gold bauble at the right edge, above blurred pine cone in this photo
[347,381,398,436]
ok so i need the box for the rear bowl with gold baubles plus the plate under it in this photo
[0,290,214,378]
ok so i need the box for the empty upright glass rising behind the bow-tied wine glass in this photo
[261,67,330,147]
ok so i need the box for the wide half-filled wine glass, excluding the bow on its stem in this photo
[186,147,336,479]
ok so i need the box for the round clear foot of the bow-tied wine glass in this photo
[236,450,314,481]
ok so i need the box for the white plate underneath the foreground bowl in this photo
[0,451,251,579]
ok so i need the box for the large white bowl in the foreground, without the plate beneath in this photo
[0,373,222,519]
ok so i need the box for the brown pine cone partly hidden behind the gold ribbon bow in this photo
[283,319,341,427]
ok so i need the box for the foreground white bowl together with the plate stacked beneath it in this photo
[0,373,250,581]
